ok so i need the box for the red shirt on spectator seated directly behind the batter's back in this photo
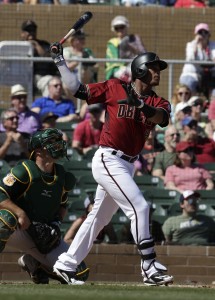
[73,119,102,148]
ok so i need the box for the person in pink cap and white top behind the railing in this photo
[179,23,215,98]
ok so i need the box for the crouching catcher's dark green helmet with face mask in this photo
[29,128,67,159]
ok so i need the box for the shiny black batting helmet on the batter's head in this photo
[131,52,167,79]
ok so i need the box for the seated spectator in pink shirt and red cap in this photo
[164,141,214,193]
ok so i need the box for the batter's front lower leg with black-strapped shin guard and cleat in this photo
[137,238,173,285]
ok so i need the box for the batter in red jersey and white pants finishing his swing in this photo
[50,43,173,285]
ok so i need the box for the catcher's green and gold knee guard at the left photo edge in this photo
[0,209,18,253]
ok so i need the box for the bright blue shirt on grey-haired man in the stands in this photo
[31,97,76,117]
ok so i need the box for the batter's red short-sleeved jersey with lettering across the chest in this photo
[86,79,171,156]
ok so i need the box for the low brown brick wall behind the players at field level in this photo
[0,244,215,284]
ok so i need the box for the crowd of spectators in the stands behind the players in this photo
[0,15,215,245]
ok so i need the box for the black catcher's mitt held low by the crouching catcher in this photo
[27,222,61,254]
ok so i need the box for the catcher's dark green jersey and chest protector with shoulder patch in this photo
[0,160,76,223]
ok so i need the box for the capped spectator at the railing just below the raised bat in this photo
[63,30,99,83]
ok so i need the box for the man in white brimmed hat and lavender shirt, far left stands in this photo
[0,84,41,134]
